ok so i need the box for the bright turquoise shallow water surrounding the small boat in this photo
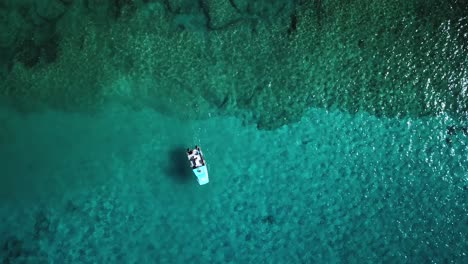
[0,102,468,263]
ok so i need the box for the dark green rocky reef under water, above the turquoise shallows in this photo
[0,0,468,129]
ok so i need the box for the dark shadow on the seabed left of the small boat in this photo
[166,146,194,183]
